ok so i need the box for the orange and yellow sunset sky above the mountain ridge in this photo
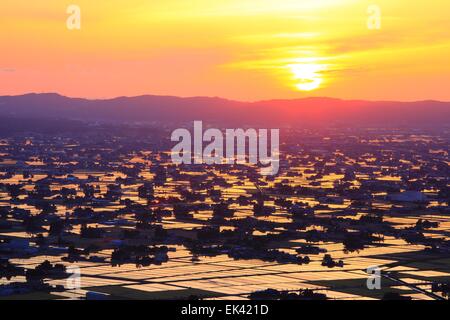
[0,0,450,101]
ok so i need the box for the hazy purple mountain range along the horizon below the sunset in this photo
[0,93,450,126]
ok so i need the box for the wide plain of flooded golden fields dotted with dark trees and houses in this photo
[0,121,450,300]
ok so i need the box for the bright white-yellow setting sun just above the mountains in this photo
[288,63,326,91]
